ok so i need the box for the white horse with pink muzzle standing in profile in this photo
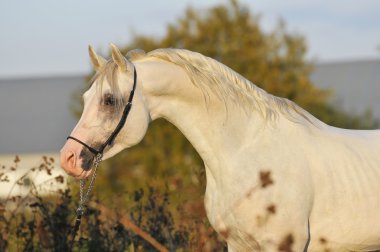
[61,45,380,251]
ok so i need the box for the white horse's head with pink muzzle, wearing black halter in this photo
[60,44,151,178]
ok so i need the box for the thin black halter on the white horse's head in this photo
[67,68,137,156]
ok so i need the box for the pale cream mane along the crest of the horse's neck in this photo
[142,48,319,125]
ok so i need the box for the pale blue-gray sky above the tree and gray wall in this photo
[0,0,380,78]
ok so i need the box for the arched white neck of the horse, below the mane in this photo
[136,58,264,170]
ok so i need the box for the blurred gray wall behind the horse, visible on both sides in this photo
[0,60,380,154]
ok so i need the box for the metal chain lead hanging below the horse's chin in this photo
[70,153,103,251]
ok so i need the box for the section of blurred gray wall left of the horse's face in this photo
[0,76,84,154]
